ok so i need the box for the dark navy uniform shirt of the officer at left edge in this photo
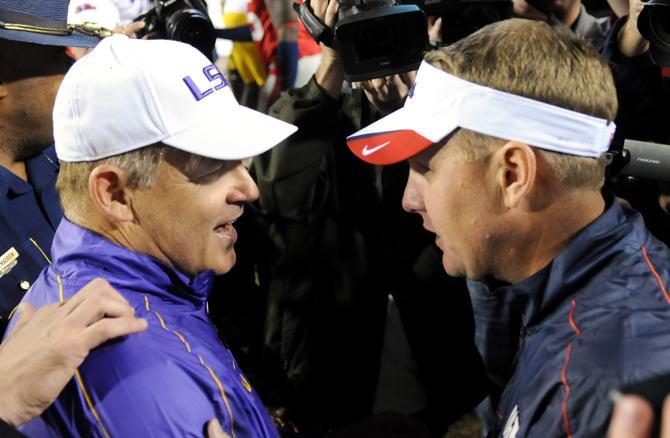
[0,147,63,336]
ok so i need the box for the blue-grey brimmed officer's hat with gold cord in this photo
[0,0,108,47]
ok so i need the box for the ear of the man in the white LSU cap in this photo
[88,164,135,222]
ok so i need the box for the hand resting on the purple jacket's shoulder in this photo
[0,278,147,426]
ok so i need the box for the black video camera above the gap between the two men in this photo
[295,0,428,81]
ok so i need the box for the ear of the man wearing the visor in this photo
[494,141,537,208]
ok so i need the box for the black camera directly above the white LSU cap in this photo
[135,0,216,60]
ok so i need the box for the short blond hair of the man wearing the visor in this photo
[426,19,617,189]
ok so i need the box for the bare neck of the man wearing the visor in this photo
[495,191,605,284]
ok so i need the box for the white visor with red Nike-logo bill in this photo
[347,61,615,164]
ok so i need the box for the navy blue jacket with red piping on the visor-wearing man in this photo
[494,202,670,438]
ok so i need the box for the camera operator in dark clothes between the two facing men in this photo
[251,0,487,436]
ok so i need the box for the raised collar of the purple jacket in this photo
[51,218,214,307]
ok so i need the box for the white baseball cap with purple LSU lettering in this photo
[53,35,297,162]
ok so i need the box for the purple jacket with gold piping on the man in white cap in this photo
[10,219,277,438]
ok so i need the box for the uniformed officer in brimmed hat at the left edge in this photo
[0,0,106,335]
